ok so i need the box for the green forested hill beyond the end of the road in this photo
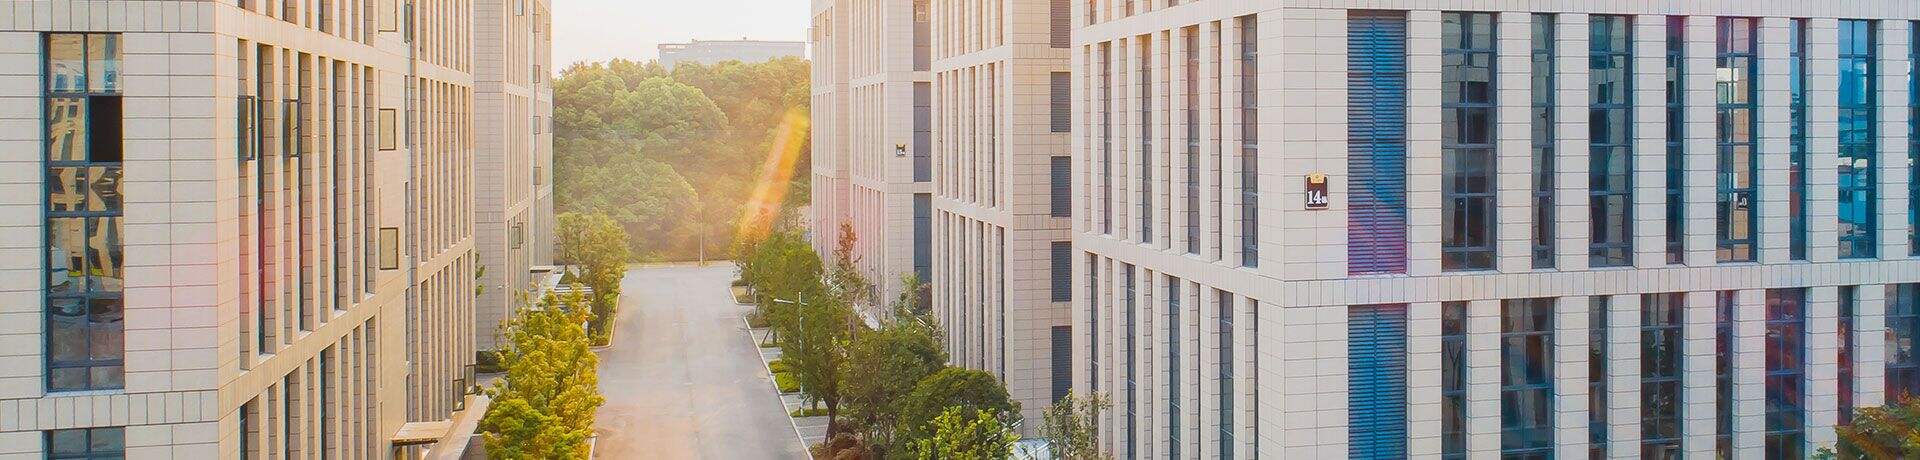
[553,58,812,261]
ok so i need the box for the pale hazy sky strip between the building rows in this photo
[553,0,812,69]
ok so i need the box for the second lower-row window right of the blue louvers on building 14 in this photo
[1500,299,1553,458]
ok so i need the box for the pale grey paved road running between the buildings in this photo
[595,265,806,460]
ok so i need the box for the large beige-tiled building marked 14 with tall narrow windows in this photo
[1071,0,1920,458]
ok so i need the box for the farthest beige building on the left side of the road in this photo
[474,0,555,351]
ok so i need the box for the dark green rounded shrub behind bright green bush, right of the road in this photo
[893,366,1020,452]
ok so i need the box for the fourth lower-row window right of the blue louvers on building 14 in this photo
[1640,293,1686,460]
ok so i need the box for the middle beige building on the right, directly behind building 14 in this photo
[916,0,1073,427]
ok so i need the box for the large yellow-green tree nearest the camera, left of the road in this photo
[480,295,605,458]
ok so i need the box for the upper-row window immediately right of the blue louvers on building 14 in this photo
[1440,13,1496,270]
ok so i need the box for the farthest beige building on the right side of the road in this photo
[808,0,933,308]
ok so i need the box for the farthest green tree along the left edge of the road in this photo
[555,213,632,339]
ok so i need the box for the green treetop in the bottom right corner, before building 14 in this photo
[1814,397,1920,460]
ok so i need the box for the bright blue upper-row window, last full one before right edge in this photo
[1839,21,1880,259]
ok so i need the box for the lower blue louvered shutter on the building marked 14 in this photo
[1346,305,1407,458]
